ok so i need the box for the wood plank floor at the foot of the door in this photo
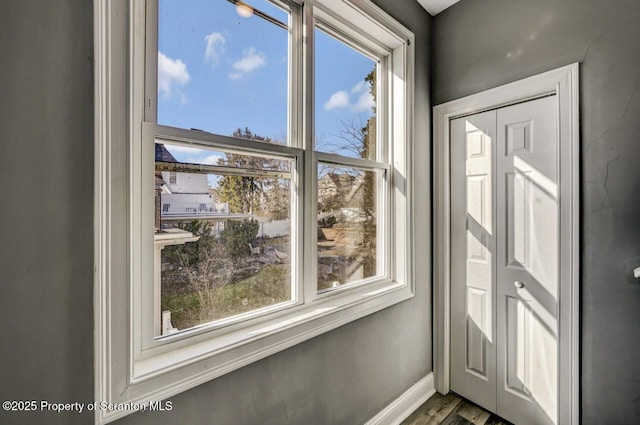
[401,393,512,425]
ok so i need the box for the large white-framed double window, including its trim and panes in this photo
[96,0,413,421]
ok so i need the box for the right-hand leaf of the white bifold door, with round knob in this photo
[495,96,559,424]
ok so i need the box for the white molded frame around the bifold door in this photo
[433,63,580,424]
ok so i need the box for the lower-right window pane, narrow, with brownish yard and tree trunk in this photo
[318,164,383,291]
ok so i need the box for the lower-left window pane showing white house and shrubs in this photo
[154,140,292,335]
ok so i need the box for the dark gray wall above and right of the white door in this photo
[432,0,640,425]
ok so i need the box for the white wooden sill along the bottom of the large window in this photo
[101,281,414,423]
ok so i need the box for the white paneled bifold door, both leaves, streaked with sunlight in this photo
[451,96,560,424]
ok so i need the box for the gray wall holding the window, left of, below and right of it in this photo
[0,0,431,425]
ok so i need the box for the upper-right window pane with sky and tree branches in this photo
[315,28,377,160]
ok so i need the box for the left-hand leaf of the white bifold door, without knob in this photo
[451,111,496,411]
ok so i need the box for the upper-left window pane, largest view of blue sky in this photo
[158,0,289,143]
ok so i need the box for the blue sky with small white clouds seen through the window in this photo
[158,0,375,163]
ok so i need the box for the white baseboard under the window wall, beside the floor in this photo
[365,373,436,425]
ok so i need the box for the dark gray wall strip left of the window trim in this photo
[0,0,93,424]
